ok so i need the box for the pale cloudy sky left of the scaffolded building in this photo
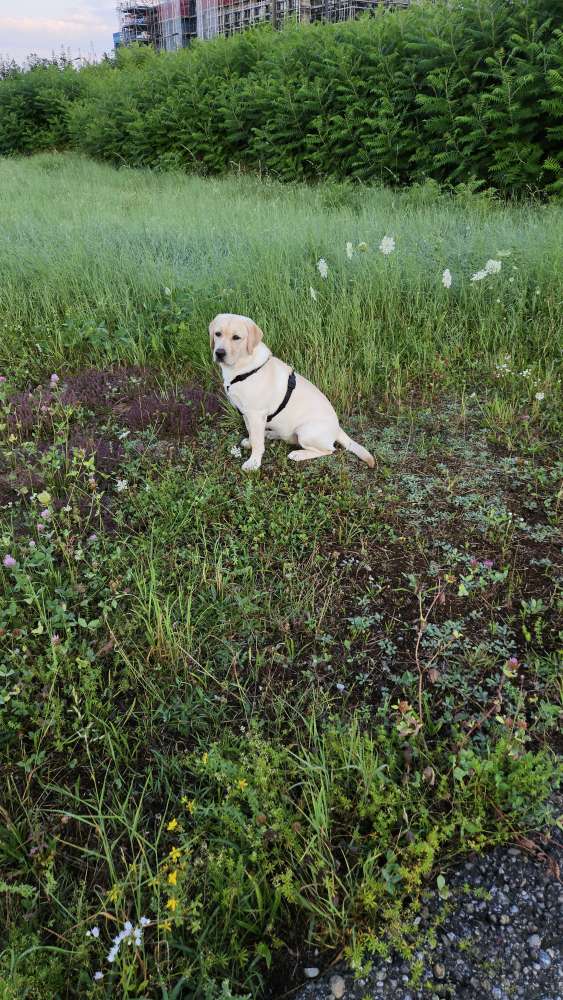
[0,0,118,63]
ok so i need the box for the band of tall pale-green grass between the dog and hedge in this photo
[0,154,563,402]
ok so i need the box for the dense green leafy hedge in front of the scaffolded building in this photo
[0,0,563,194]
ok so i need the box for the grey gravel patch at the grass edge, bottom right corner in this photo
[290,843,563,1000]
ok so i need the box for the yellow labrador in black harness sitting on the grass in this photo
[209,313,375,471]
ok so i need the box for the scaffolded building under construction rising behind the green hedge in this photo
[117,0,409,51]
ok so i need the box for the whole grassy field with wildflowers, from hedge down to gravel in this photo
[0,154,563,1000]
